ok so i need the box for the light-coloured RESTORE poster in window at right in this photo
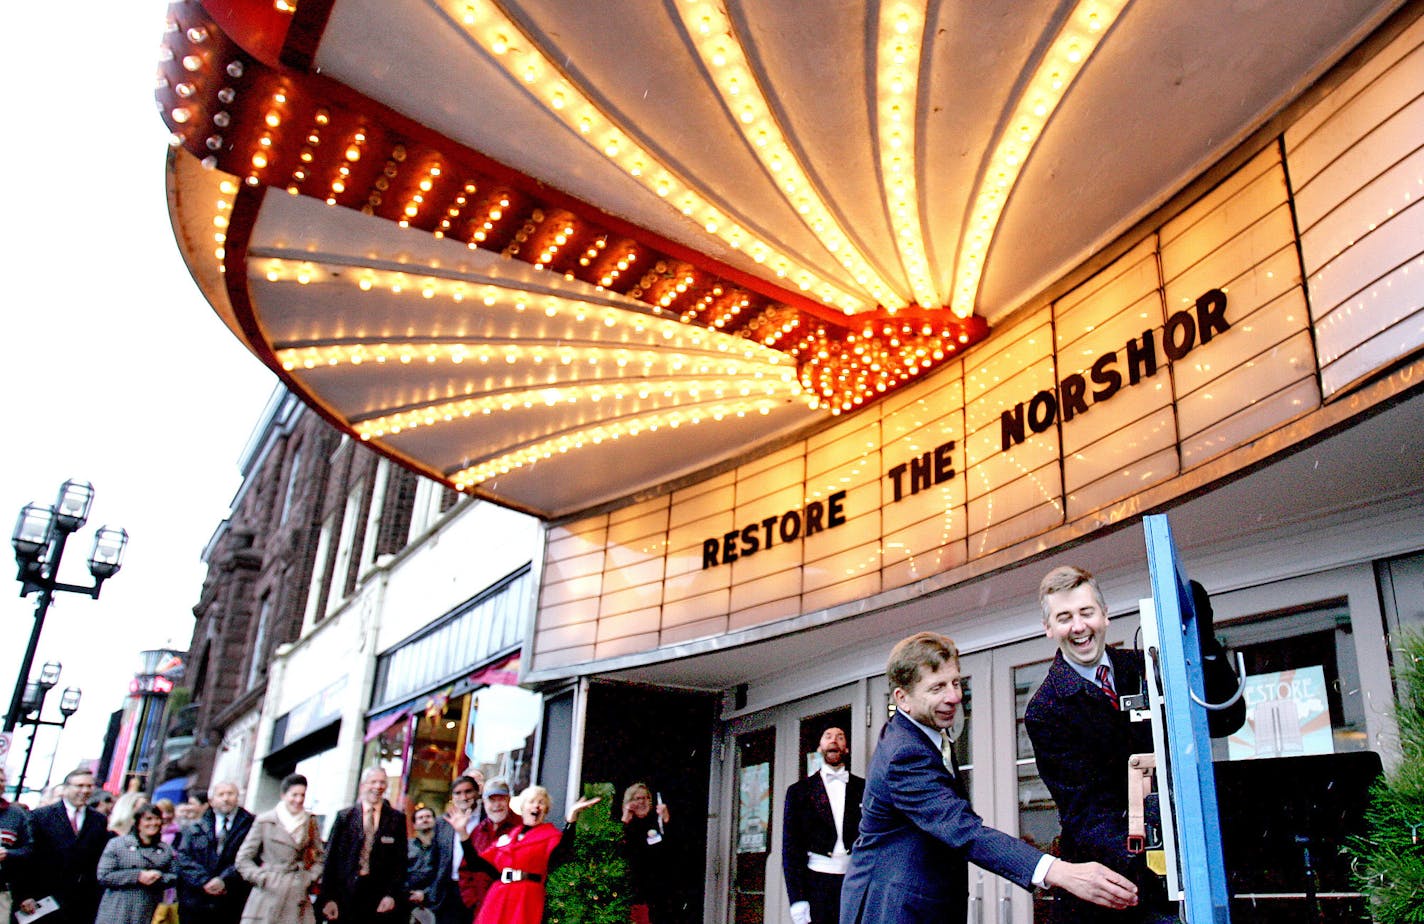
[1227,665,1334,760]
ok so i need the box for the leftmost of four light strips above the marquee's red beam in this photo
[440,0,874,313]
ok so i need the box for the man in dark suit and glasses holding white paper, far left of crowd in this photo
[14,770,110,924]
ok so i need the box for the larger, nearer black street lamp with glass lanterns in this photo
[4,480,128,735]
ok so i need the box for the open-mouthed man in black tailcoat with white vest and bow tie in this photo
[782,728,866,924]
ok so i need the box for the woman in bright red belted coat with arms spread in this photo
[474,786,600,924]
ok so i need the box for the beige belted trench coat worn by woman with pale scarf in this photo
[238,810,323,924]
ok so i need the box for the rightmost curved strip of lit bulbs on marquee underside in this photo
[951,0,1128,317]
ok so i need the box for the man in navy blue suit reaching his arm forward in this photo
[840,632,1136,924]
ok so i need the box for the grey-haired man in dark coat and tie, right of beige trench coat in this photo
[316,767,407,924]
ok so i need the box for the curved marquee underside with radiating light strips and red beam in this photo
[157,0,1397,517]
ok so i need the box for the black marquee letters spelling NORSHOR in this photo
[996,289,1230,449]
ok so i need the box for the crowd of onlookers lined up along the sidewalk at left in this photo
[0,767,674,924]
